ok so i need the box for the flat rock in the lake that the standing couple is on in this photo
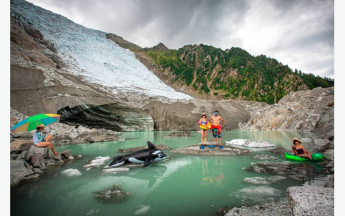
[170,144,251,156]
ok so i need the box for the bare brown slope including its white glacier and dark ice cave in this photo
[11,0,267,132]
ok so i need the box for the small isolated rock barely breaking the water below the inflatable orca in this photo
[95,184,133,203]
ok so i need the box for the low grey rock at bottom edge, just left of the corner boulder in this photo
[225,201,292,216]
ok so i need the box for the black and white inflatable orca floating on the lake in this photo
[109,141,167,167]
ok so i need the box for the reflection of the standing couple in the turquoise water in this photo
[200,157,224,186]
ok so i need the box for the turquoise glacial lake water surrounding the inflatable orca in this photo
[11,131,325,216]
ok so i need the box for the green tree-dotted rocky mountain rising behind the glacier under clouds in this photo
[107,34,334,104]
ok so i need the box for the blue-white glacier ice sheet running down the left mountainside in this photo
[11,0,193,100]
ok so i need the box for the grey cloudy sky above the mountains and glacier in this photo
[28,0,334,78]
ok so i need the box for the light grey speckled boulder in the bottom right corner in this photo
[286,186,334,216]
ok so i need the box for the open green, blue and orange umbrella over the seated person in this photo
[11,114,60,133]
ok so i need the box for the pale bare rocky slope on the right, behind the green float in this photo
[239,87,334,137]
